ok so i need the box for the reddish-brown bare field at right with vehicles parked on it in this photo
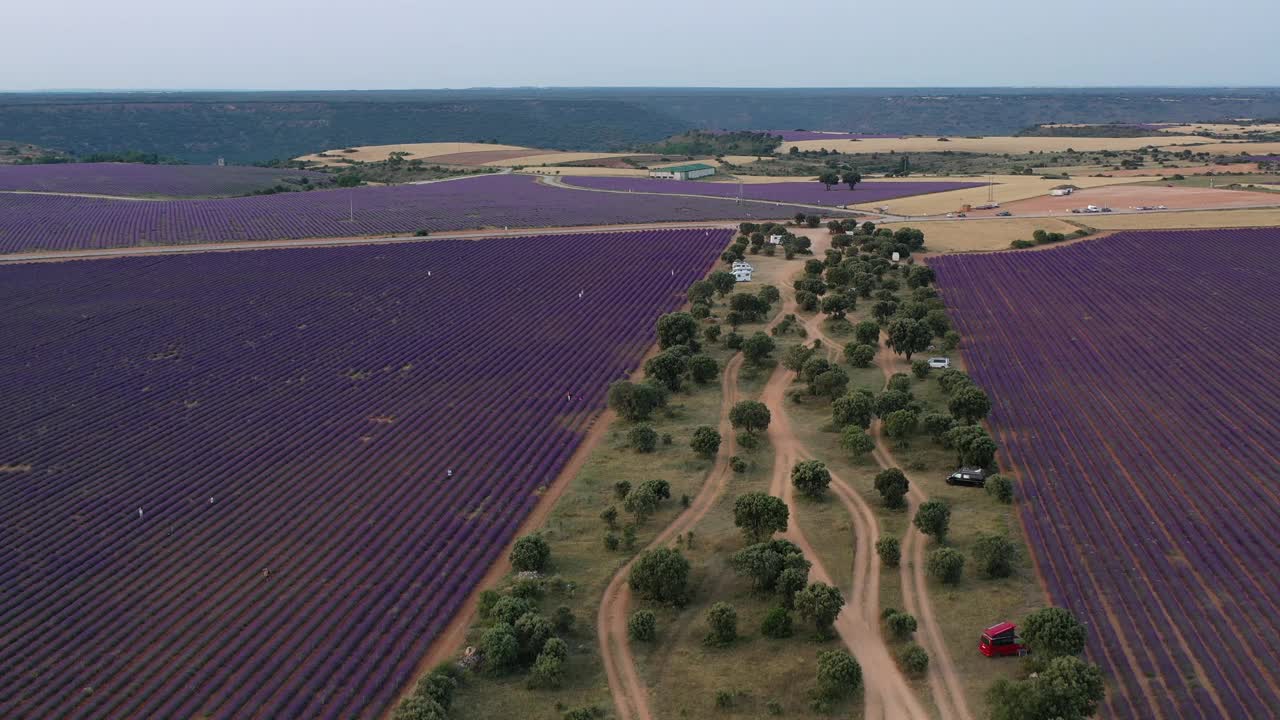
[972,184,1280,213]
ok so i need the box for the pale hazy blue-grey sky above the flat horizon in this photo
[0,0,1280,90]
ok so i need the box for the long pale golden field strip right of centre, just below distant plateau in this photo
[778,135,1206,154]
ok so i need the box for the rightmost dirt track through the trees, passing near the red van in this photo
[872,332,973,720]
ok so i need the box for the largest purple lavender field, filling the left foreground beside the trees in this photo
[0,229,731,720]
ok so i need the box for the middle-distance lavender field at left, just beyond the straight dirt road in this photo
[0,174,839,252]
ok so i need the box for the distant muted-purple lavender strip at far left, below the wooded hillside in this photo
[0,163,332,197]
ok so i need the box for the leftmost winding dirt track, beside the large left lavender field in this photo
[595,354,742,720]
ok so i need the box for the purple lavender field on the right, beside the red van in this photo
[929,228,1280,719]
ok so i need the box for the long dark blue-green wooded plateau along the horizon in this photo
[0,88,1280,163]
